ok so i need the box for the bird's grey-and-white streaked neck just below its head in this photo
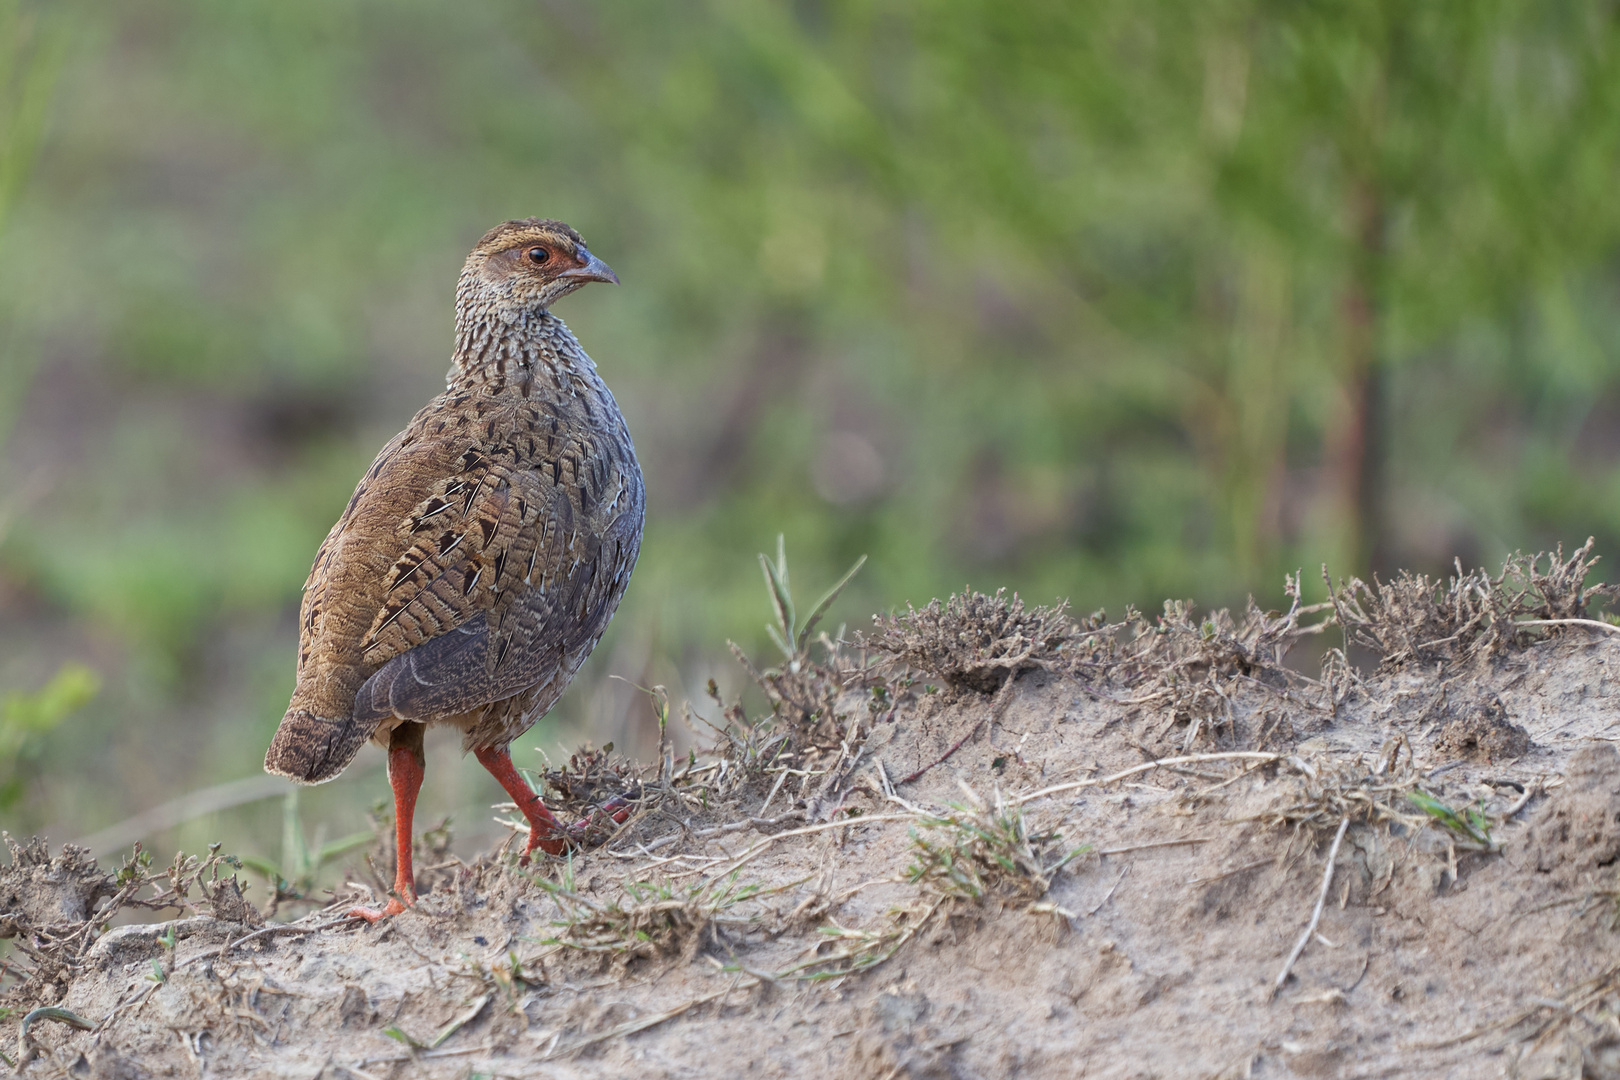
[446,304,596,395]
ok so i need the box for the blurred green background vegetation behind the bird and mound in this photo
[0,0,1620,899]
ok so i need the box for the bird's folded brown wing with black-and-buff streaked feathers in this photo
[356,453,640,719]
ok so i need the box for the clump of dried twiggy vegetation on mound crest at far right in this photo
[1324,538,1620,669]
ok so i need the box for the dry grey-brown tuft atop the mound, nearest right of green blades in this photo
[860,589,1084,693]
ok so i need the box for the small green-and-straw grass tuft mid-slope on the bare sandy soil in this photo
[906,787,1092,904]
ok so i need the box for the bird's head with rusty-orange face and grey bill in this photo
[457,217,619,319]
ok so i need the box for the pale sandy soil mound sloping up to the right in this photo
[9,586,1620,1080]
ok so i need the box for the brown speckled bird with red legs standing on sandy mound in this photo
[264,217,646,923]
